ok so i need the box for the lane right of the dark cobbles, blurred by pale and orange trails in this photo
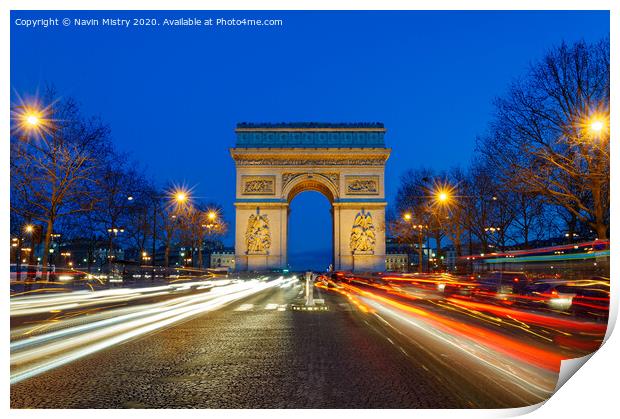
[318,288,557,407]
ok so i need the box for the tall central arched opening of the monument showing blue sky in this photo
[287,189,334,271]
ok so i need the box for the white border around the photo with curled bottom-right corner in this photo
[0,0,620,418]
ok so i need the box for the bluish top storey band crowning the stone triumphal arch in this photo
[235,122,386,148]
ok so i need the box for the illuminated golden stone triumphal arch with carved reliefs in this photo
[230,123,390,272]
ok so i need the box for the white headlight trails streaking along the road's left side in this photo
[11,278,291,384]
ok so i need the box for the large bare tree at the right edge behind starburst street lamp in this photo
[479,40,609,239]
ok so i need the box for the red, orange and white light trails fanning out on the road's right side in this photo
[324,281,606,402]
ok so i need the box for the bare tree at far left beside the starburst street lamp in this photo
[11,89,111,278]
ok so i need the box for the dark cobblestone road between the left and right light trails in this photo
[11,285,518,408]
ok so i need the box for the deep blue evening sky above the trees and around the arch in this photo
[11,11,609,268]
